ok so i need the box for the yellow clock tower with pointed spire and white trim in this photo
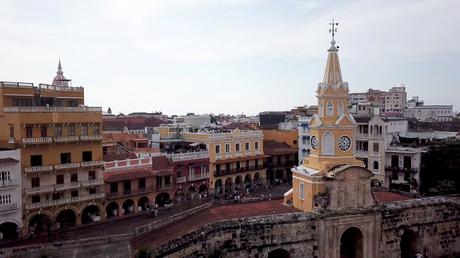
[292,34,363,211]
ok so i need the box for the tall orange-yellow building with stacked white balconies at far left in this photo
[0,65,105,233]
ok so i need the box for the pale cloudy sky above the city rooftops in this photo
[0,0,460,114]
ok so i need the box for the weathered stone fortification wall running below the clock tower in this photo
[155,196,460,258]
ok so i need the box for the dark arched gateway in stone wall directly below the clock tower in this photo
[340,227,363,258]
